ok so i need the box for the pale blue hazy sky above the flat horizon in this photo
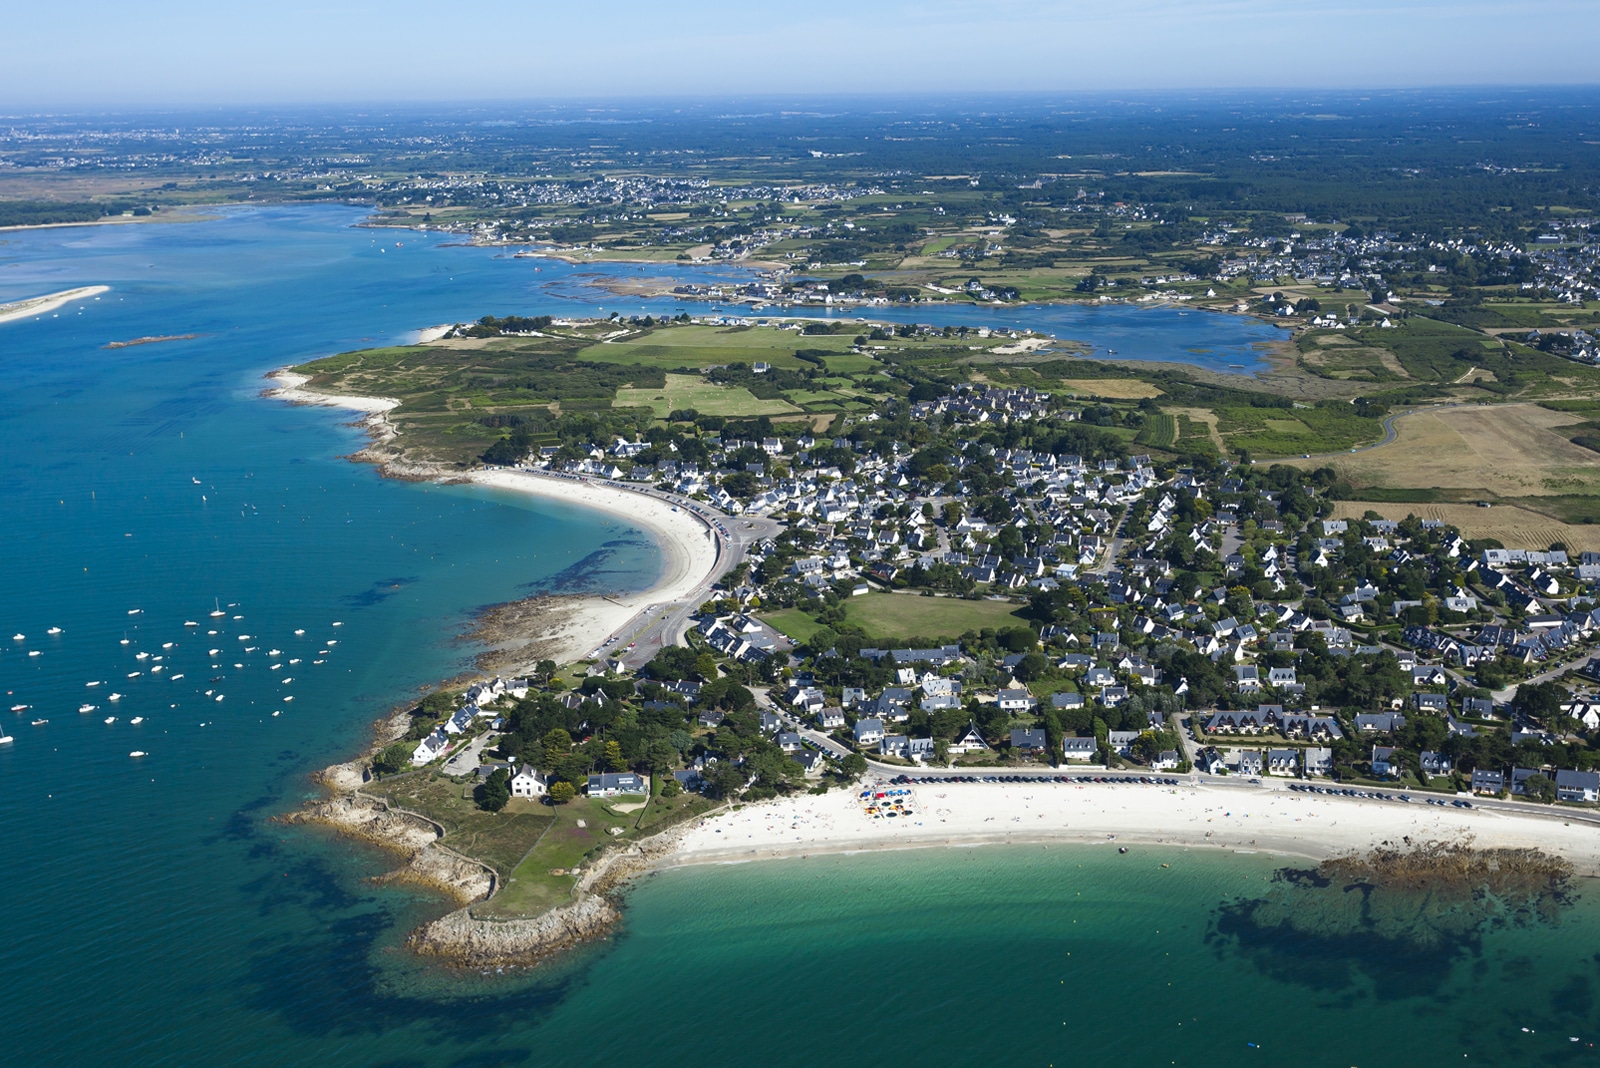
[0,0,1600,112]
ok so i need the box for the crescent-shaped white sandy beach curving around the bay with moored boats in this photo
[470,470,717,660]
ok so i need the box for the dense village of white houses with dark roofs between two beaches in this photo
[394,374,1600,806]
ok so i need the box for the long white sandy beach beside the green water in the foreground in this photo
[666,782,1600,875]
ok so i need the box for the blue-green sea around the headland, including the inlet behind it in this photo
[0,208,1600,1066]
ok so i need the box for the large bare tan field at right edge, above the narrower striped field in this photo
[1286,404,1600,497]
